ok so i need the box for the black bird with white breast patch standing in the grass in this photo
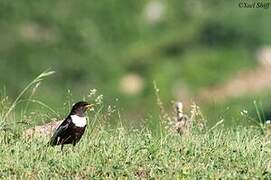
[50,101,94,150]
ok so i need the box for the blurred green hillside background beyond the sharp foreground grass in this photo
[0,0,271,124]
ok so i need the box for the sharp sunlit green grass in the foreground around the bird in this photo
[0,72,271,179]
